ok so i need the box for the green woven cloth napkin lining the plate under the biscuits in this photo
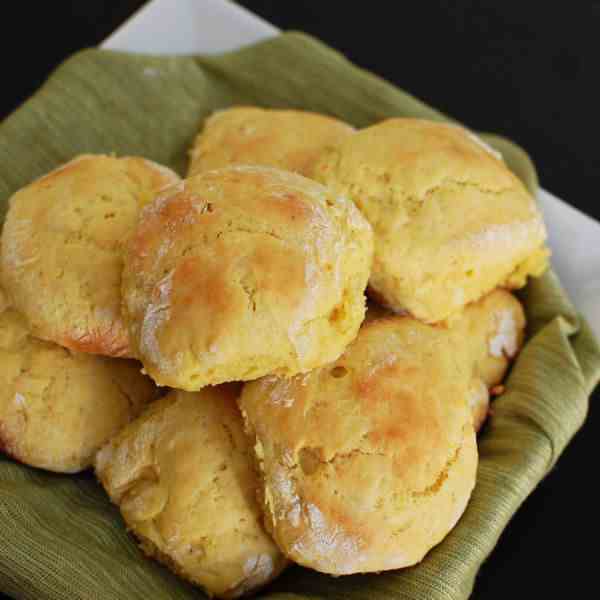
[0,33,600,600]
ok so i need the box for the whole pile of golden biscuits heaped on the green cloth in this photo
[0,107,548,598]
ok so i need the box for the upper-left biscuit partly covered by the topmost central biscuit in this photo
[2,155,179,356]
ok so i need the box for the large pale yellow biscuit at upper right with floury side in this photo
[311,118,548,323]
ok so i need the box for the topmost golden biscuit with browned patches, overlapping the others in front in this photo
[123,166,372,391]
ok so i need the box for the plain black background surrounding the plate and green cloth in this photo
[0,0,600,600]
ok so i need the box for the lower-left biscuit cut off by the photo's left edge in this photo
[0,308,158,473]
